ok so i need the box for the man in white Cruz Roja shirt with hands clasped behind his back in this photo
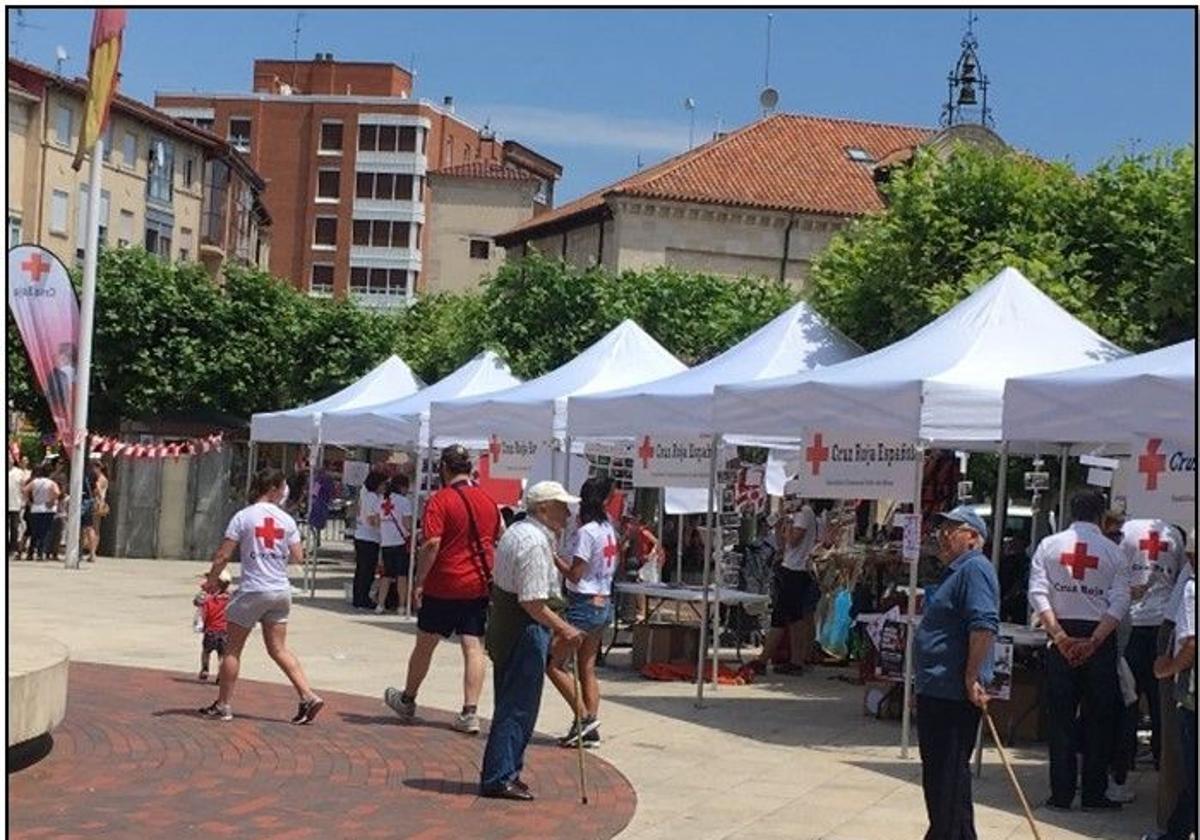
[1030,490,1130,810]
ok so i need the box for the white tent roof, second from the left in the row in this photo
[320,350,521,446]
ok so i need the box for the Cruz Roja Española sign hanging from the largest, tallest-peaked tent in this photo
[797,427,922,502]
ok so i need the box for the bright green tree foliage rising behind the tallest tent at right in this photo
[811,148,1195,350]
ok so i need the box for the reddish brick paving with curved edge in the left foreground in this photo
[8,662,636,840]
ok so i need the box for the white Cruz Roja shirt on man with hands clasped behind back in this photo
[1030,522,1129,622]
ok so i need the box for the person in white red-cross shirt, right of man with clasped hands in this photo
[1121,520,1183,768]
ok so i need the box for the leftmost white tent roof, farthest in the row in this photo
[250,355,424,443]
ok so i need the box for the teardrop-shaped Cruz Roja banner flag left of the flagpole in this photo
[8,245,79,440]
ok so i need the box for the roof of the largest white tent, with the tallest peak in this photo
[714,268,1127,448]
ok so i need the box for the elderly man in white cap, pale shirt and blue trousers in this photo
[480,481,583,802]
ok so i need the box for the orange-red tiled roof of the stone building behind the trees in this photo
[497,114,937,245]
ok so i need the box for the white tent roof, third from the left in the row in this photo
[430,320,686,444]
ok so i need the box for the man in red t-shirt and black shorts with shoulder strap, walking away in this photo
[383,444,504,734]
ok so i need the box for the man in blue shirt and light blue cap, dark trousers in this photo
[914,506,1000,840]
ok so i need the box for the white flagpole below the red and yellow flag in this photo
[64,134,104,569]
